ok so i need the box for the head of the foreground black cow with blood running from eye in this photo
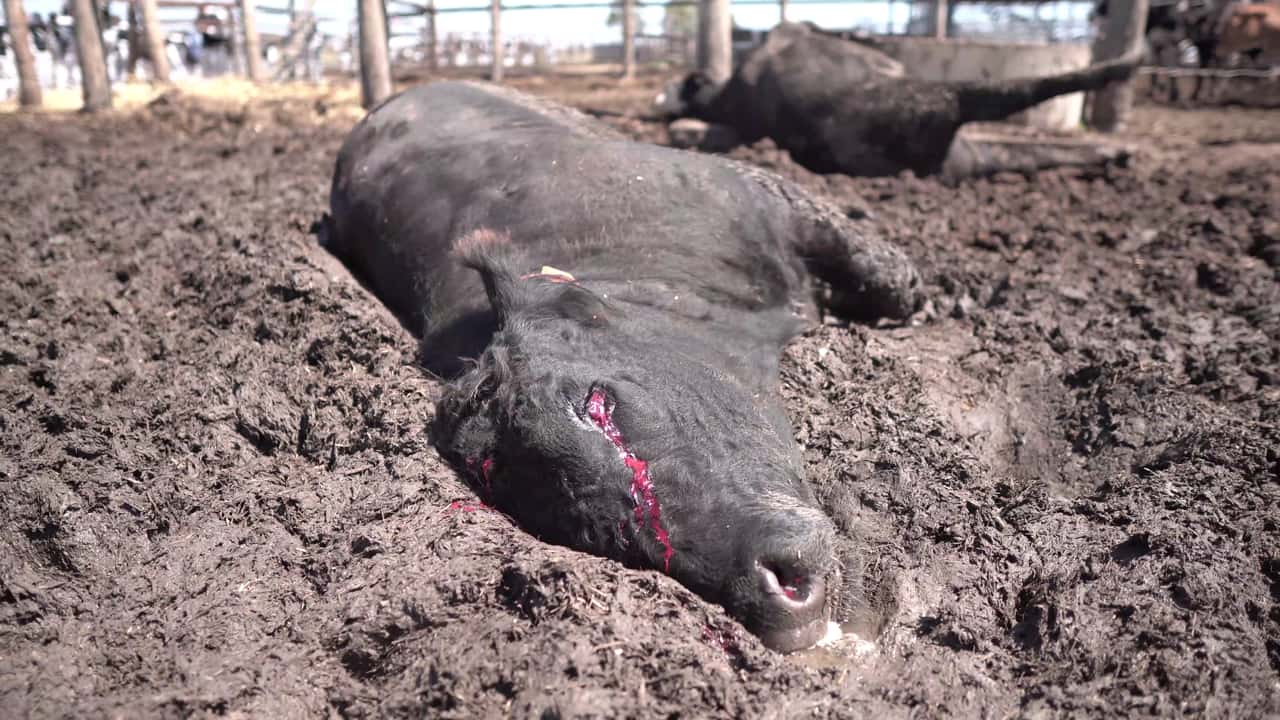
[433,232,841,651]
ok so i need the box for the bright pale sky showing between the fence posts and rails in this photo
[10,0,1088,46]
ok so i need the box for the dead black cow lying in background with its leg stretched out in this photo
[658,23,1142,176]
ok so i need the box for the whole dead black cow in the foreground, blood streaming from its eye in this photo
[324,82,919,651]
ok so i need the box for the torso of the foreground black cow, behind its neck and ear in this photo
[328,82,818,363]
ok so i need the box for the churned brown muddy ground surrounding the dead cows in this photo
[0,75,1280,717]
